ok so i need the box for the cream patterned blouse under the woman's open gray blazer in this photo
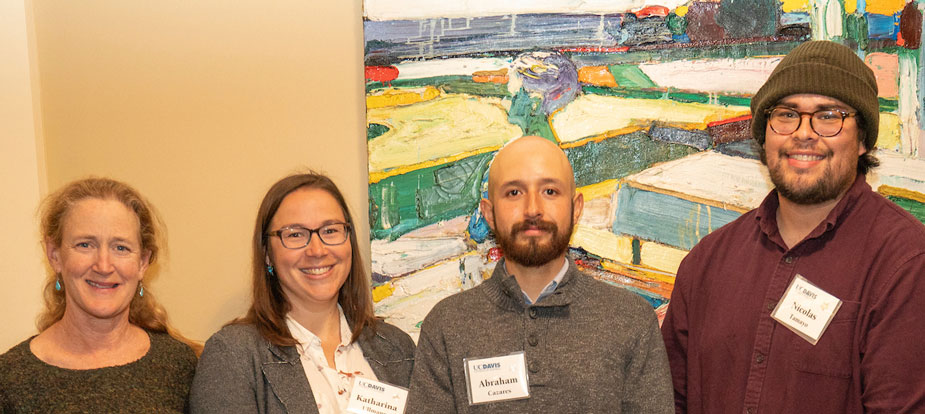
[286,305,377,414]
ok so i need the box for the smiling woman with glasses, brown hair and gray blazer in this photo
[190,173,414,414]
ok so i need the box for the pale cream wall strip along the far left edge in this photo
[0,1,45,352]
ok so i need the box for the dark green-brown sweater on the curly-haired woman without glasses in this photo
[0,332,196,414]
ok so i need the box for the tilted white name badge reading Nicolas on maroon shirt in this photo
[771,274,841,345]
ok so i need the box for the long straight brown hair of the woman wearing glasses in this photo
[231,172,378,346]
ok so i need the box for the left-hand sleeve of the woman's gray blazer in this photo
[190,330,261,414]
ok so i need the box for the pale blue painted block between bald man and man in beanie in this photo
[613,185,741,250]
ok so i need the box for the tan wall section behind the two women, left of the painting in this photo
[0,0,368,350]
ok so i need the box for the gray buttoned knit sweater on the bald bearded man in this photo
[405,262,674,414]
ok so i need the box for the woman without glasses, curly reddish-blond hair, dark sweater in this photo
[0,178,201,413]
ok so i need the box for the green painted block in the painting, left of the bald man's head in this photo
[369,153,493,240]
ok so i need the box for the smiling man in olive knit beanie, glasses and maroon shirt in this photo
[662,41,925,413]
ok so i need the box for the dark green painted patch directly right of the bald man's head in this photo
[565,131,698,187]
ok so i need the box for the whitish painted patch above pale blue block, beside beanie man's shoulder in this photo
[625,151,773,210]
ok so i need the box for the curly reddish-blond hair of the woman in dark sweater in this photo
[36,177,202,354]
